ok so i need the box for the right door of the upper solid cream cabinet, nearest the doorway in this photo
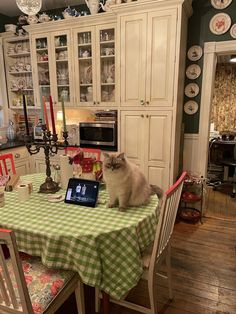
[146,10,177,107]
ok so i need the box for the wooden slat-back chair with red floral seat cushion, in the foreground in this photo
[0,229,85,314]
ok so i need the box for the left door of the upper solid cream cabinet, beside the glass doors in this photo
[120,13,147,106]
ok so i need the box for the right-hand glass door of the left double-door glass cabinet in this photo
[51,31,74,107]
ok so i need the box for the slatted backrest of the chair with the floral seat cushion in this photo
[0,229,33,314]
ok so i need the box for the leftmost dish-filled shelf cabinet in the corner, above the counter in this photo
[3,36,36,109]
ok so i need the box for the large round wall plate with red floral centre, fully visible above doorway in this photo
[209,13,231,35]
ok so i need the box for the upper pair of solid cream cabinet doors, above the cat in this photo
[120,9,177,107]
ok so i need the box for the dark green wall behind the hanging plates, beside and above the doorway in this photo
[183,0,236,133]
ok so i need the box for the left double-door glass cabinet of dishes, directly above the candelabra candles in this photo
[31,30,74,107]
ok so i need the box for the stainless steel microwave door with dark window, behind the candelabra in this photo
[79,121,117,147]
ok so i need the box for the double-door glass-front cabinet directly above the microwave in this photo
[74,24,116,106]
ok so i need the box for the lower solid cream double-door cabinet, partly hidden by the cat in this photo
[121,110,172,189]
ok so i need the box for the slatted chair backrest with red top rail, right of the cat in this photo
[150,172,187,268]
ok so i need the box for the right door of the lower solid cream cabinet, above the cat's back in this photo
[143,111,172,190]
